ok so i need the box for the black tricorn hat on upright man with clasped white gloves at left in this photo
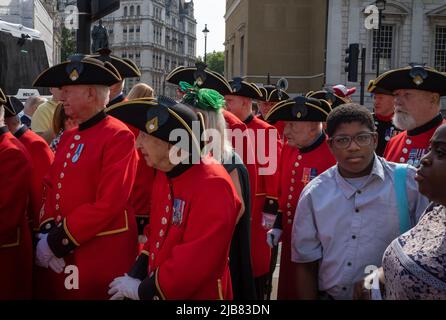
[33,54,122,88]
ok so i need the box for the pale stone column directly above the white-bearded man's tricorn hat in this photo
[410,0,424,63]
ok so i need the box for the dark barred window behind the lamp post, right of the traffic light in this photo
[371,25,395,72]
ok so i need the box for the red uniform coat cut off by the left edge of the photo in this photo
[0,127,33,300]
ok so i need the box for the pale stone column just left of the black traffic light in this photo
[325,0,346,84]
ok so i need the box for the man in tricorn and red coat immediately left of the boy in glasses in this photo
[266,96,336,299]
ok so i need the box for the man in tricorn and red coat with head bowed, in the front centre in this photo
[107,98,241,300]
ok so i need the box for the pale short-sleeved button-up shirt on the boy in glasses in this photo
[291,156,429,299]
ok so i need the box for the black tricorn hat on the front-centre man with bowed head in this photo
[105,96,204,154]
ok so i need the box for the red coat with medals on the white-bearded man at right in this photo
[384,115,444,167]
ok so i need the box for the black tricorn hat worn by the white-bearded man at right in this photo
[371,63,446,96]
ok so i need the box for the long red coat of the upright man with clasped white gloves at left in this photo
[37,112,137,299]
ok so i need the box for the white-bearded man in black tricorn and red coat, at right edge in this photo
[369,64,446,167]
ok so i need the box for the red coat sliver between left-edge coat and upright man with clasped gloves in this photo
[14,126,54,231]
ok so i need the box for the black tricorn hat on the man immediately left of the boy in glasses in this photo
[265,96,331,123]
